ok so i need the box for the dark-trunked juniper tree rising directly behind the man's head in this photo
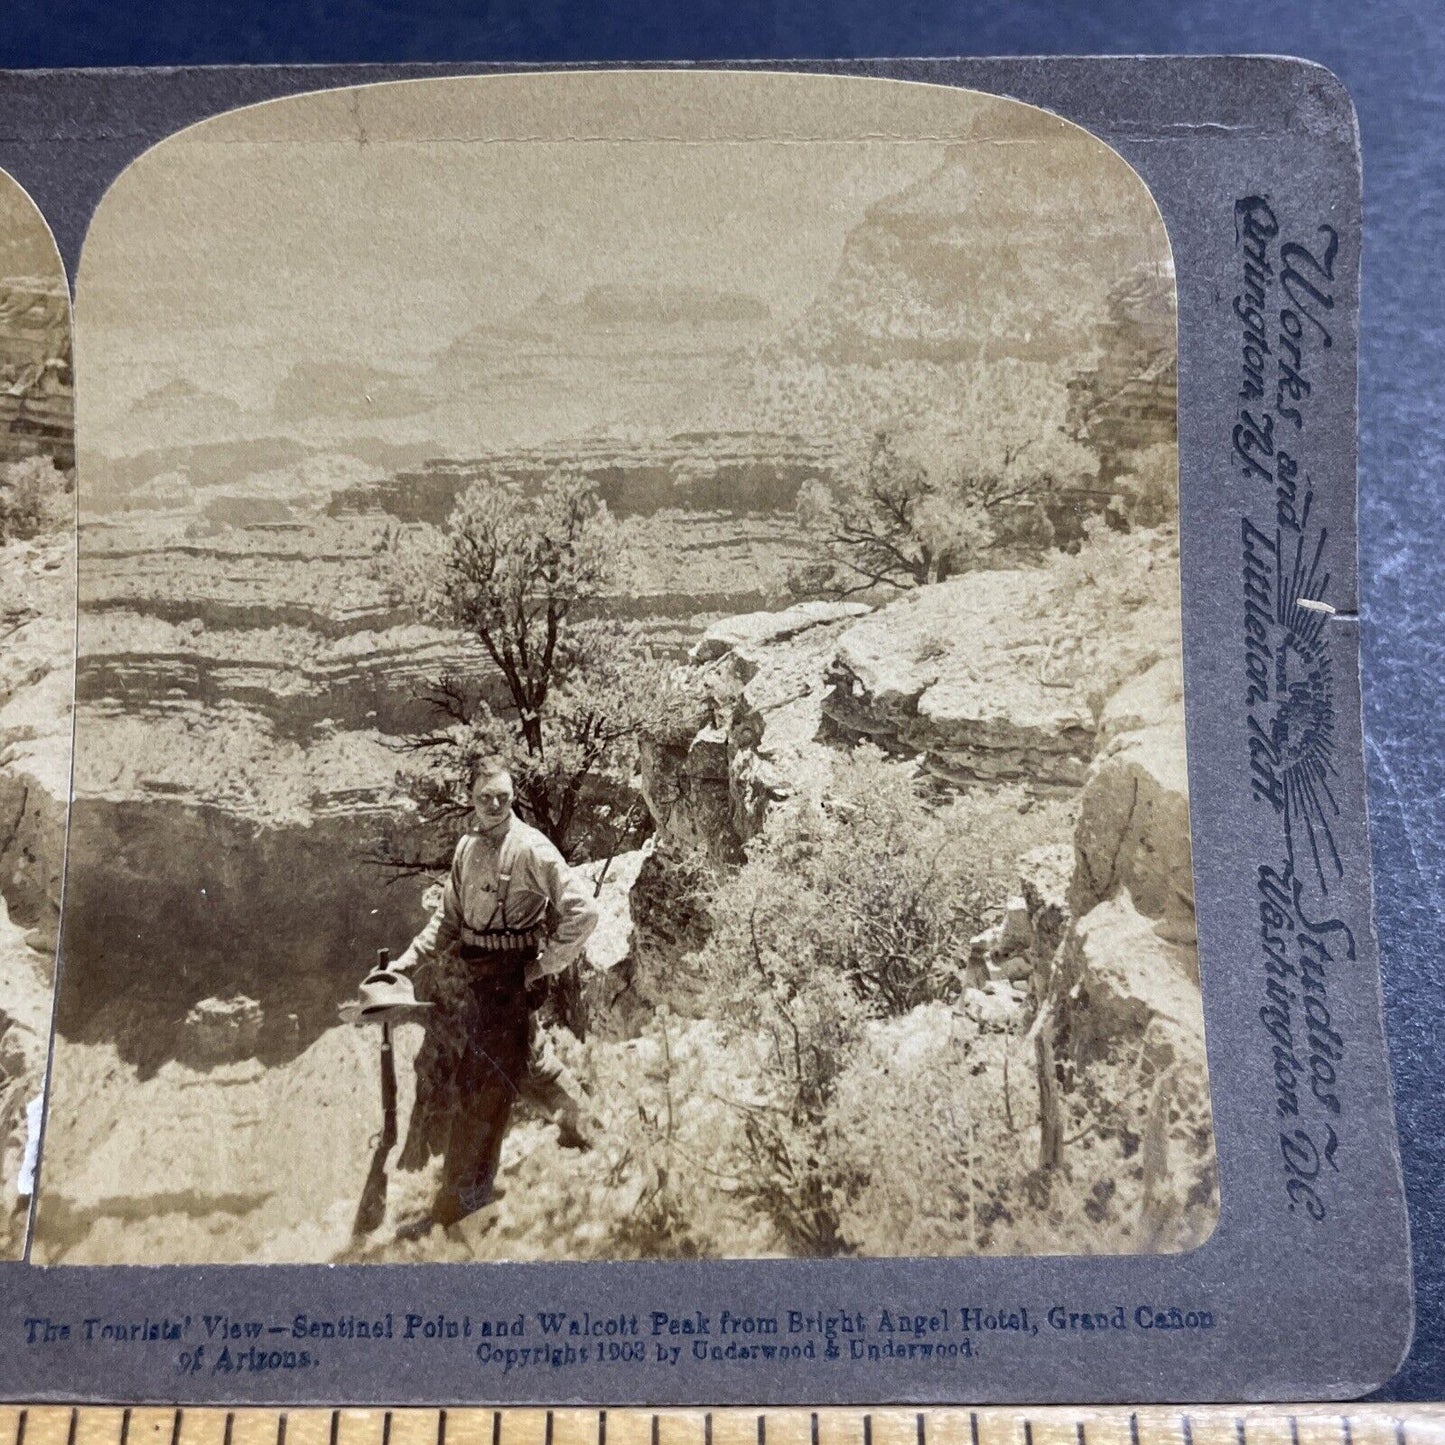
[377,473,662,874]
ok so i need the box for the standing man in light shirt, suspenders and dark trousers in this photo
[378,756,597,1225]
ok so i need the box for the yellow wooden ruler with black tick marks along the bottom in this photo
[0,1405,1445,1445]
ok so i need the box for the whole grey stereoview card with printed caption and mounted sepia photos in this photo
[0,58,1410,1405]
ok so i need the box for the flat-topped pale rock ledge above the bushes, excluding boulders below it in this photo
[643,530,1188,855]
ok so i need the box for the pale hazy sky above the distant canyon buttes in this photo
[77,72,1161,452]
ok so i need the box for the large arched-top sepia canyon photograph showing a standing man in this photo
[28,71,1218,1264]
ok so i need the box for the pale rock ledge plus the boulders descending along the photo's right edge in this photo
[639,530,1212,1202]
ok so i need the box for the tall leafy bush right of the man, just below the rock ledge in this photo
[696,747,1038,1254]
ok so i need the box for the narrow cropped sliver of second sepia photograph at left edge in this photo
[0,164,75,1260]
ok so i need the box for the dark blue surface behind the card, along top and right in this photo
[0,0,1445,1399]
